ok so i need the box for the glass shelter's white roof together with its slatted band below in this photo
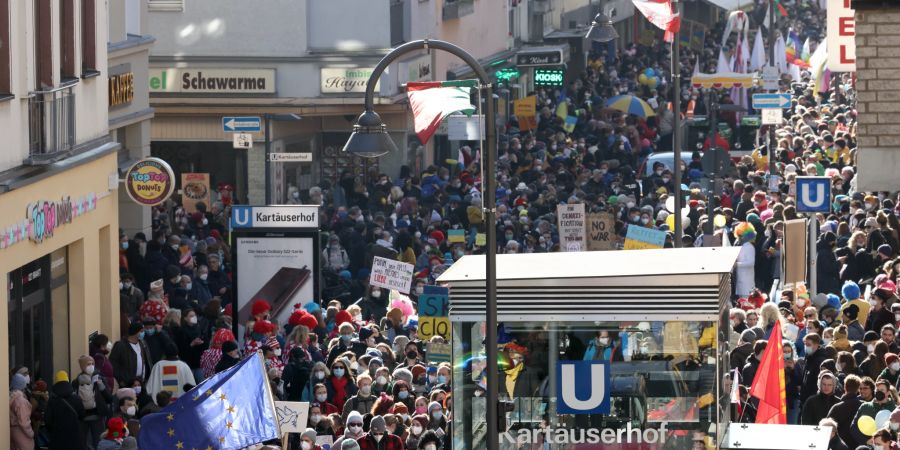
[437,247,740,322]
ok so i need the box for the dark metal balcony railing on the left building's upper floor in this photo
[25,85,75,165]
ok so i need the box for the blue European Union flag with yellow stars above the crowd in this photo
[138,353,280,450]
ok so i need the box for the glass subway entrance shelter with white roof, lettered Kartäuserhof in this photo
[438,248,739,450]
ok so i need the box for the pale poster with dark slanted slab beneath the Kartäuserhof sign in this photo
[234,234,317,338]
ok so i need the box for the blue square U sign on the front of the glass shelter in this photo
[556,361,610,414]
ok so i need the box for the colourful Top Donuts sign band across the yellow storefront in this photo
[0,193,98,249]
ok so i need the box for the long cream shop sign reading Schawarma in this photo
[150,67,275,94]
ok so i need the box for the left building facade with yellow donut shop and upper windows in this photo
[0,0,119,442]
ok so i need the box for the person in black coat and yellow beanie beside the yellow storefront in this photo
[44,370,87,450]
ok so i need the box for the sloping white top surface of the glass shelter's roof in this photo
[438,247,740,282]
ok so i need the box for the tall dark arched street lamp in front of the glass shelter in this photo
[343,39,500,450]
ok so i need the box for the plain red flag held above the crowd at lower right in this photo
[750,321,787,425]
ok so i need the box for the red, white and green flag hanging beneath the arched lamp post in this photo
[406,80,477,144]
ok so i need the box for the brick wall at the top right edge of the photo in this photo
[856,5,900,191]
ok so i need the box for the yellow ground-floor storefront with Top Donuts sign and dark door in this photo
[0,149,119,383]
